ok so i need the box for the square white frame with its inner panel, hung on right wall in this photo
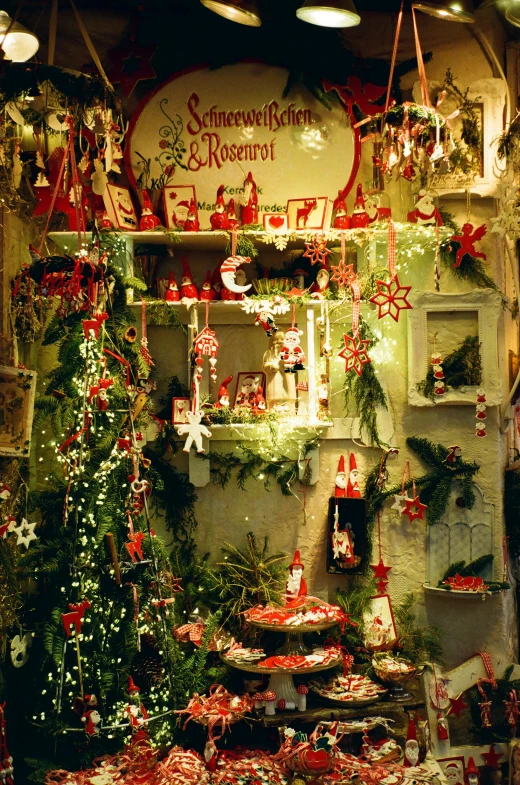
[408,289,502,406]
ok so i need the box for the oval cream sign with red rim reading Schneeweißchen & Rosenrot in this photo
[125,62,361,229]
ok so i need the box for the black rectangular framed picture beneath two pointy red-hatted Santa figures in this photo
[327,496,368,575]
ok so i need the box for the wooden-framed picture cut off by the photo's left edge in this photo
[0,365,36,456]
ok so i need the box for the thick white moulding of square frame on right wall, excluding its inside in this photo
[407,289,503,407]
